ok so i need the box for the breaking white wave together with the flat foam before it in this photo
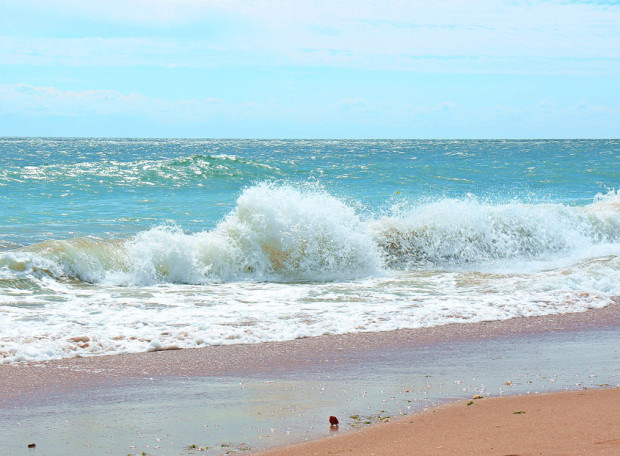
[0,184,620,362]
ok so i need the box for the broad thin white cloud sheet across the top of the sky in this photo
[0,0,620,74]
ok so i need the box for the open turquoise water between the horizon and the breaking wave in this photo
[0,138,620,245]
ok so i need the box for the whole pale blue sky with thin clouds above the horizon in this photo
[0,0,620,138]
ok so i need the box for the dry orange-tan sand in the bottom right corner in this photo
[260,388,620,456]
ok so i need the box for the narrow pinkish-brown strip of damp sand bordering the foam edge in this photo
[0,302,620,402]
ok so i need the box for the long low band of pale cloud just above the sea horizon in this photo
[0,84,620,137]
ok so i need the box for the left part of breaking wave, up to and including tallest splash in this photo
[0,183,382,285]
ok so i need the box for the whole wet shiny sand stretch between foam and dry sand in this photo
[0,304,620,456]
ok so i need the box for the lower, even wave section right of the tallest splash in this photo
[371,192,620,269]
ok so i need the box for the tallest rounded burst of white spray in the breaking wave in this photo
[216,184,381,280]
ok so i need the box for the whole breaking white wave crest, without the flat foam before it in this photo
[0,183,620,285]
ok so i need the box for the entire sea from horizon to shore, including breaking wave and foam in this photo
[0,138,620,363]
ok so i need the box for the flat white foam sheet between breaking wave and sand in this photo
[0,256,620,362]
